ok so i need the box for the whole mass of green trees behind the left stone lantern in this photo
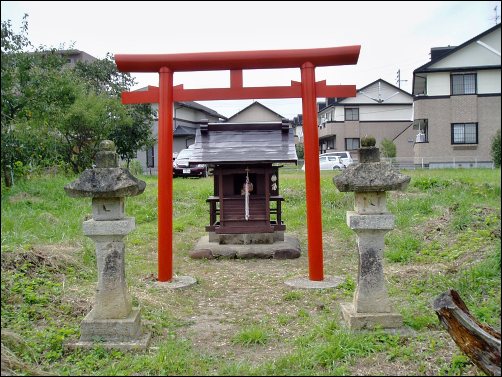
[1,15,152,182]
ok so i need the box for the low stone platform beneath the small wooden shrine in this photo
[189,234,301,259]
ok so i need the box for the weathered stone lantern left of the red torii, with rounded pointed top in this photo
[64,140,150,349]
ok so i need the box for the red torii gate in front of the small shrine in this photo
[115,45,361,282]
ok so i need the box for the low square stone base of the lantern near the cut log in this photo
[340,303,403,330]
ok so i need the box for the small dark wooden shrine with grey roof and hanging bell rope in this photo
[190,120,299,256]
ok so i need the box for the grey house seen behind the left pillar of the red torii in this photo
[137,98,227,174]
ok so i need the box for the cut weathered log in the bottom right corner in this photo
[433,289,500,376]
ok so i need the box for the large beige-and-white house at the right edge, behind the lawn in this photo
[413,24,501,168]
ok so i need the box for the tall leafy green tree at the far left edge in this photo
[1,15,68,187]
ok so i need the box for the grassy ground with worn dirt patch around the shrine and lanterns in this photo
[1,168,501,375]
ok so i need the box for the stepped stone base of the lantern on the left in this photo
[65,308,151,350]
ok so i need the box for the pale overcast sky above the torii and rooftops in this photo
[1,1,501,119]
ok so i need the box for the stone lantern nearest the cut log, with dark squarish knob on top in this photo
[333,147,410,329]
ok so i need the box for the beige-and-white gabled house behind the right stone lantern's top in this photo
[318,79,415,160]
